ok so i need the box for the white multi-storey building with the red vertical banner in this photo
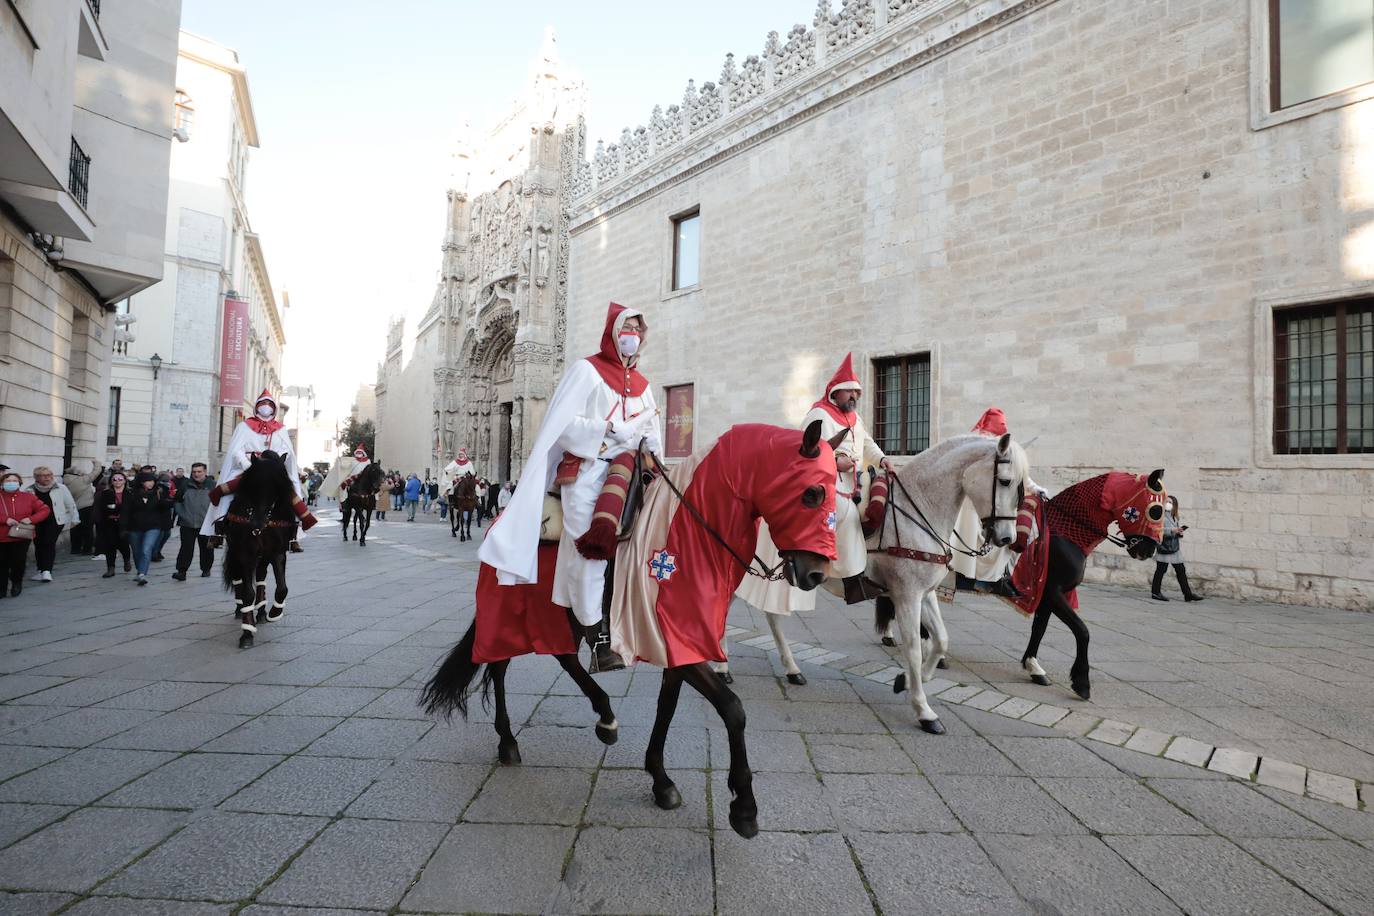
[106,32,289,467]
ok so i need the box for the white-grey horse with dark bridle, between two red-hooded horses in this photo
[717,434,1029,735]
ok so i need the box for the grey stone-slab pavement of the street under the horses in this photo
[0,514,1374,916]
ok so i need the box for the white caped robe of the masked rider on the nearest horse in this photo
[477,360,662,625]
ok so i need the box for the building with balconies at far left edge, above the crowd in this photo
[0,0,181,474]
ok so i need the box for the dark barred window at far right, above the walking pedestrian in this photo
[1274,299,1374,455]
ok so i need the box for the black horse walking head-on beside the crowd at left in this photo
[224,450,297,648]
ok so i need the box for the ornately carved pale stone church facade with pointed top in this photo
[376,34,584,481]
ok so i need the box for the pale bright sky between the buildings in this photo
[181,0,815,411]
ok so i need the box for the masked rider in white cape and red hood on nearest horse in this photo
[477,302,662,672]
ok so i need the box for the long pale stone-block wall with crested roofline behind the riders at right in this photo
[566,0,1374,610]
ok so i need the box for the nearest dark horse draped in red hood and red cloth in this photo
[420,423,837,836]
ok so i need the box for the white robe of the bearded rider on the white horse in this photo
[735,407,886,614]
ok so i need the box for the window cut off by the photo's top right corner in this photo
[1270,0,1374,110]
